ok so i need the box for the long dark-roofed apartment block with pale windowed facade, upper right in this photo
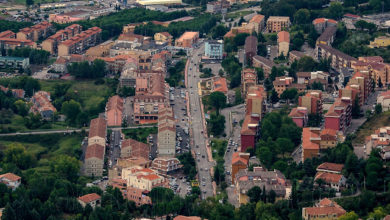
[316,44,357,71]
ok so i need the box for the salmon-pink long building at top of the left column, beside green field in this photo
[105,95,123,126]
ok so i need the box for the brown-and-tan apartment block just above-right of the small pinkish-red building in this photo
[298,90,322,114]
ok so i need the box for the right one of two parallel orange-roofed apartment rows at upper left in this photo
[58,27,102,56]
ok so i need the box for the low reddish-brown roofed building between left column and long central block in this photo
[121,139,150,160]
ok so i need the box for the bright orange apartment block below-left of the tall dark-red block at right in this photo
[301,128,321,162]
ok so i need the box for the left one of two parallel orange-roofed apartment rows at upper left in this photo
[42,24,82,54]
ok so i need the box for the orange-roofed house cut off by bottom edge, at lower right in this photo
[302,198,347,220]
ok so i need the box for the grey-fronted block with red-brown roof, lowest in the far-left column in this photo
[83,144,105,177]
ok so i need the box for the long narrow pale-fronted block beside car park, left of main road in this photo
[157,107,176,157]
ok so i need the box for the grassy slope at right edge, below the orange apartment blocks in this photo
[354,111,390,144]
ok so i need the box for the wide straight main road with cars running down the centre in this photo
[186,43,214,199]
